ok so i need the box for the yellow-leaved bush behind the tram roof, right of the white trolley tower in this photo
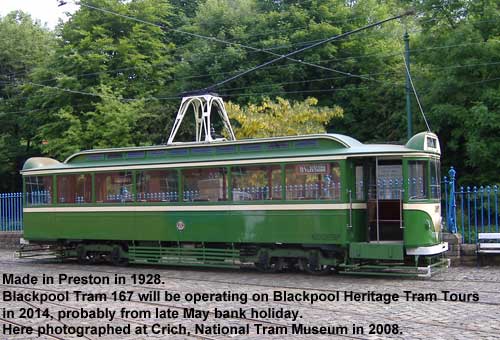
[227,97,343,138]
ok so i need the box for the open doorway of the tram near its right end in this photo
[367,158,403,242]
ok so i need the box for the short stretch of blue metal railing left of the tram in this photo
[0,192,23,231]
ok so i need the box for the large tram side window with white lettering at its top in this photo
[285,163,340,200]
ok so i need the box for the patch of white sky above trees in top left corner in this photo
[0,0,78,29]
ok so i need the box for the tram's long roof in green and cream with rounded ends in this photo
[21,132,440,174]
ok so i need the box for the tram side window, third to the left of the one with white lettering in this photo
[137,170,179,202]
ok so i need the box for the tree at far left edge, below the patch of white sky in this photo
[0,11,56,191]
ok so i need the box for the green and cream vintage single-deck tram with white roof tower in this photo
[21,95,448,276]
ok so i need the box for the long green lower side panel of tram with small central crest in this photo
[24,207,366,245]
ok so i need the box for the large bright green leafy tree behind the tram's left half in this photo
[24,0,178,158]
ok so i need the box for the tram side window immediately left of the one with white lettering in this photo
[231,165,281,201]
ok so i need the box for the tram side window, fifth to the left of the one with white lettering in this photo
[57,175,92,204]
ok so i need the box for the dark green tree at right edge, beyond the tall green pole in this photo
[413,0,500,184]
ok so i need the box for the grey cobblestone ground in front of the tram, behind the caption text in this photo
[0,250,500,340]
